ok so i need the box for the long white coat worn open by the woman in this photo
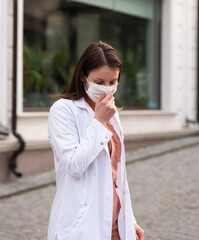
[48,98,136,240]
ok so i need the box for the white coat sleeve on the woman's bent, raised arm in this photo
[48,101,112,178]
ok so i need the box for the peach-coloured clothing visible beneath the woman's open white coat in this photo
[84,95,121,240]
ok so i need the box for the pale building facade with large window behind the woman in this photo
[0,0,199,181]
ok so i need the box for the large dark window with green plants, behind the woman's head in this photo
[23,0,160,111]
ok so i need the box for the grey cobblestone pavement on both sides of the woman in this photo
[0,137,199,240]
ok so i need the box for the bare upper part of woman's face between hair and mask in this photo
[88,65,119,80]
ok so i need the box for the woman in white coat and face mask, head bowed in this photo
[48,41,144,240]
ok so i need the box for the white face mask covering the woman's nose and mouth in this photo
[84,76,117,102]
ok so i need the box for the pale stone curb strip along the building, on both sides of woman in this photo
[0,137,199,200]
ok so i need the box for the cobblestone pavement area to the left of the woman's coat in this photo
[0,186,55,240]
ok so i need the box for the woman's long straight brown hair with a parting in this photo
[57,41,122,100]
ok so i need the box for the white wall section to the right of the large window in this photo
[161,0,197,127]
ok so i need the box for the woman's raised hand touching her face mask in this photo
[95,92,116,125]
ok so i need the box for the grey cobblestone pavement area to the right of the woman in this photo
[127,145,199,240]
